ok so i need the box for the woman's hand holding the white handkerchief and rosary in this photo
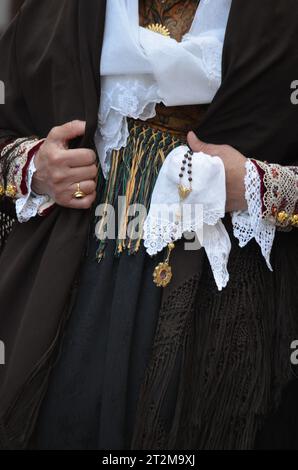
[187,132,247,212]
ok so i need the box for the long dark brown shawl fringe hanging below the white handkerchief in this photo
[132,235,297,450]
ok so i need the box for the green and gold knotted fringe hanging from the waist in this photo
[96,120,183,261]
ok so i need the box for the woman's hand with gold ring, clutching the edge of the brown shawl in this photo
[32,121,98,209]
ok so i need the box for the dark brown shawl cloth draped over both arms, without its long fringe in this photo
[0,0,298,448]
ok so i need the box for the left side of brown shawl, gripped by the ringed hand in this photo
[0,0,105,448]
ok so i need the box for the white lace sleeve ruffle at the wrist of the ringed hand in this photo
[16,157,54,223]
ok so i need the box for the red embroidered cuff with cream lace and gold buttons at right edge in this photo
[252,160,298,229]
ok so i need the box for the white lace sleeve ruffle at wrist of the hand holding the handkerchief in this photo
[232,160,276,271]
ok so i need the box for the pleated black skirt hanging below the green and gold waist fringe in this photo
[35,233,161,450]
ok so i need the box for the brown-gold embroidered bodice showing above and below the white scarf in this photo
[139,0,208,136]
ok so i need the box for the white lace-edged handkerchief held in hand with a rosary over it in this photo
[144,146,231,290]
